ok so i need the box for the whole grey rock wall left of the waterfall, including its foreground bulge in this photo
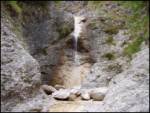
[1,2,73,111]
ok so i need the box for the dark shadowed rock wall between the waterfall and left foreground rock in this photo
[22,2,73,84]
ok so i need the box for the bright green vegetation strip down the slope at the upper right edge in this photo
[121,1,149,57]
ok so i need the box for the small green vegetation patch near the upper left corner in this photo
[7,1,22,14]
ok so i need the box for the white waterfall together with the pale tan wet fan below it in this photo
[53,16,91,88]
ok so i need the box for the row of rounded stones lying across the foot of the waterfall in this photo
[41,85,108,101]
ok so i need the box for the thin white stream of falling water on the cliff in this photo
[73,16,84,65]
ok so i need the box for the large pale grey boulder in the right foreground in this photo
[104,48,149,112]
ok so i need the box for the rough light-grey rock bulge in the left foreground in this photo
[1,18,41,111]
